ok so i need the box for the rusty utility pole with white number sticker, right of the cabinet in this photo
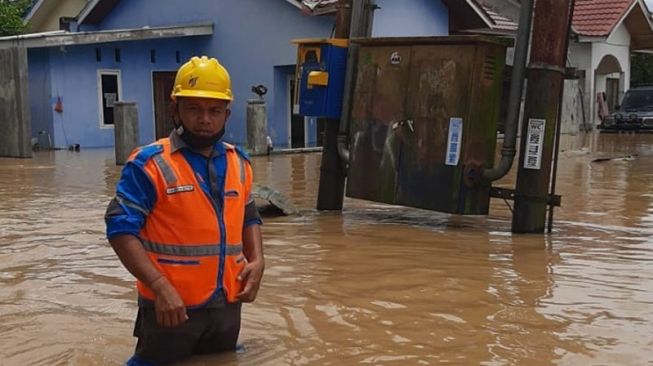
[512,0,571,233]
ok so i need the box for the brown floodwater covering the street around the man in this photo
[0,134,653,366]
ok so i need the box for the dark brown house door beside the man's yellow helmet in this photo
[152,71,176,139]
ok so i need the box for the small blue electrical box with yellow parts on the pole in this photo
[294,38,348,118]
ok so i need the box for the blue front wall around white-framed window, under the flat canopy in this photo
[41,37,201,147]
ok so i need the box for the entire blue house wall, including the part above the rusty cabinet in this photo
[33,0,448,148]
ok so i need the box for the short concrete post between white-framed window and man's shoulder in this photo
[113,102,139,165]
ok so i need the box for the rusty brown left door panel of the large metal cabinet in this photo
[347,47,411,203]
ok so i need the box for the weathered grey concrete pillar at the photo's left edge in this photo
[0,47,32,158]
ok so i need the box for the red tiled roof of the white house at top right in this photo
[573,0,636,37]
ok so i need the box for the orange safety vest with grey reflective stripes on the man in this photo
[133,138,252,307]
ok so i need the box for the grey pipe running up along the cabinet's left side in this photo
[338,0,375,169]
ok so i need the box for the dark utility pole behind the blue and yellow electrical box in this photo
[317,0,374,211]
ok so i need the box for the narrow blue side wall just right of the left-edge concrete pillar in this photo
[28,49,54,146]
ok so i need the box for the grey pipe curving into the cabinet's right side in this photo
[483,0,533,181]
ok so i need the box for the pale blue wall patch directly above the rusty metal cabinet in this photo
[372,0,448,37]
